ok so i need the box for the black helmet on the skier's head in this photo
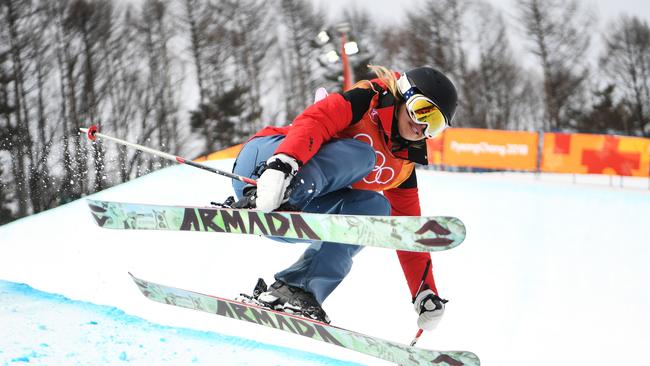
[398,66,458,125]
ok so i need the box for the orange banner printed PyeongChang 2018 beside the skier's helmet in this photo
[440,128,539,171]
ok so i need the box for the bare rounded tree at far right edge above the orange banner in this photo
[600,16,650,136]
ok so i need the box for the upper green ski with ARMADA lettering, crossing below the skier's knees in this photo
[88,199,465,252]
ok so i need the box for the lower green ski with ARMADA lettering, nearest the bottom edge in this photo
[129,273,480,366]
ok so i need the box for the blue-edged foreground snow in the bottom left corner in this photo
[0,281,354,365]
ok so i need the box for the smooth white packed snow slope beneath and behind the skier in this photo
[0,160,650,366]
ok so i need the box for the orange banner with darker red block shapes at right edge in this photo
[541,133,650,177]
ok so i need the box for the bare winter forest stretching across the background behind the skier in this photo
[0,0,650,224]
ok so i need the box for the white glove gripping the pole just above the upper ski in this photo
[255,154,299,212]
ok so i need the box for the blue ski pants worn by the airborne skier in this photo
[233,135,391,304]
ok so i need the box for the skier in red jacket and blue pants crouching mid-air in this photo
[233,66,457,330]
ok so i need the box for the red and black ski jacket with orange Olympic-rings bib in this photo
[253,79,438,296]
